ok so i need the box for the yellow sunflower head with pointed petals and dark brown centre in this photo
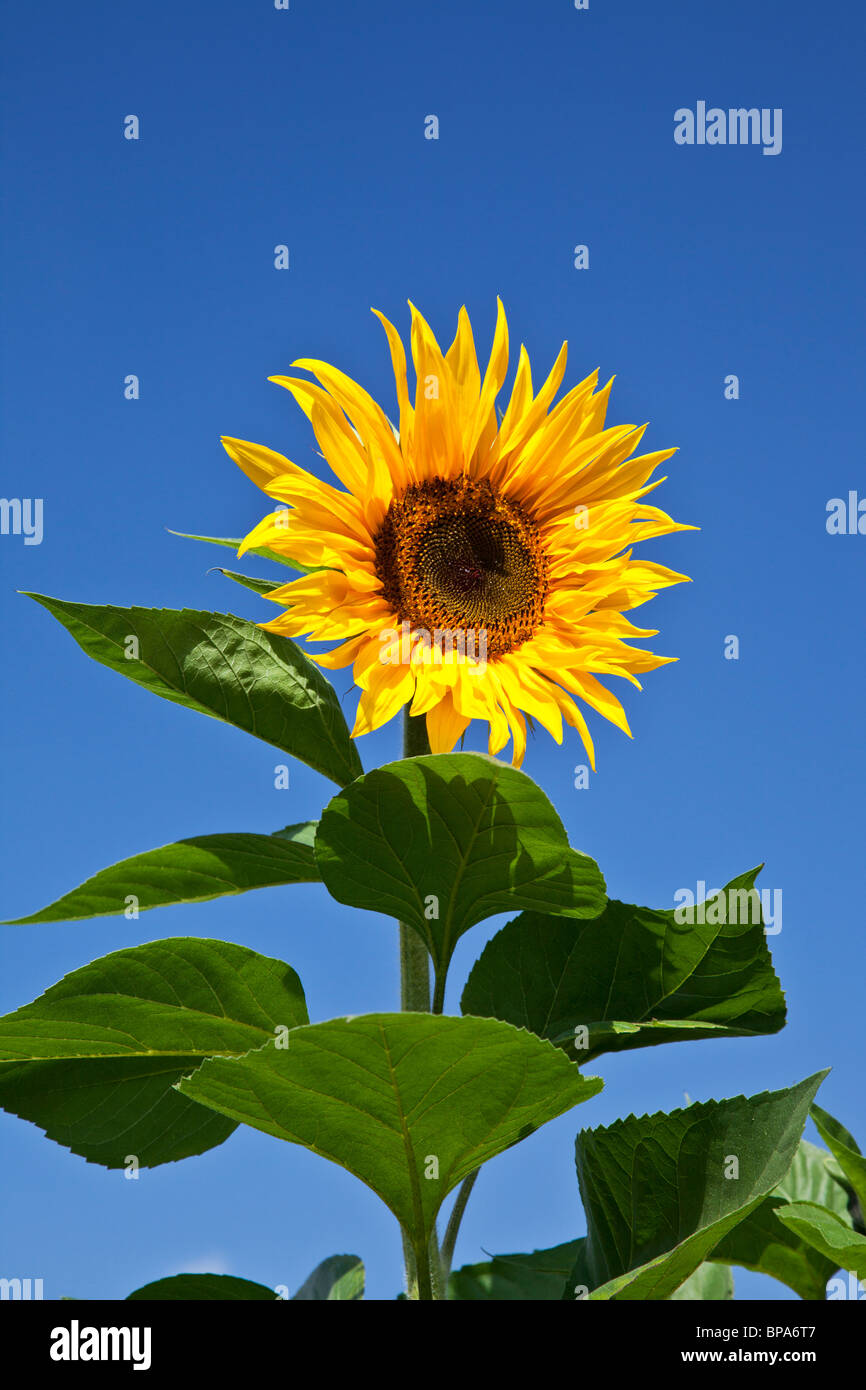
[222,302,694,767]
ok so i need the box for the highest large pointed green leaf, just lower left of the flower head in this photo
[28,594,363,787]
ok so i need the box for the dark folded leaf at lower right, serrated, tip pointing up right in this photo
[571,1072,827,1300]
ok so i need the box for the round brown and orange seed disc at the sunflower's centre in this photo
[375,478,548,657]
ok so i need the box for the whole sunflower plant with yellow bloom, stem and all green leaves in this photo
[0,304,866,1300]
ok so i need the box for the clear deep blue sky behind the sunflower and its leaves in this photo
[0,0,866,1298]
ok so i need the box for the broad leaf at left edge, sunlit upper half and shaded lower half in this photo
[0,937,307,1168]
